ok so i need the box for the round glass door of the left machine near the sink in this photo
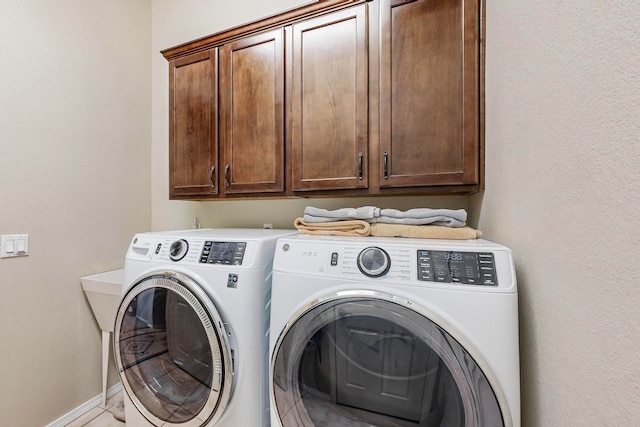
[114,272,233,427]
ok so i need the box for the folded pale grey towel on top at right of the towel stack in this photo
[375,208,467,227]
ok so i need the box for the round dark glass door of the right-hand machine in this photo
[271,291,505,427]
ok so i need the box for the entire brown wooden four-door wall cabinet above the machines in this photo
[162,0,484,199]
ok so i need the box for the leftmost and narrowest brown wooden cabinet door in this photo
[169,49,218,198]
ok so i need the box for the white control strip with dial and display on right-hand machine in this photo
[273,234,516,292]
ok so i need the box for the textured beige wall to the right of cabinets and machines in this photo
[480,0,640,427]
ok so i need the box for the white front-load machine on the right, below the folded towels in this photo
[269,235,520,427]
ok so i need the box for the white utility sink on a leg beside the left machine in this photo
[80,270,124,405]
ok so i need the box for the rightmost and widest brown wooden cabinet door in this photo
[379,0,480,187]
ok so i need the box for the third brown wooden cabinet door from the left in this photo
[291,4,368,191]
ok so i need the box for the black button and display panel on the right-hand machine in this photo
[418,250,498,286]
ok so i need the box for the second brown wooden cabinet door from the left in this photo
[220,29,284,194]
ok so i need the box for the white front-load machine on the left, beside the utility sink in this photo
[114,229,294,427]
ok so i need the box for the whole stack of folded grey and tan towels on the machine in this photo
[294,206,482,240]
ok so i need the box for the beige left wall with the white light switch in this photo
[0,0,151,427]
